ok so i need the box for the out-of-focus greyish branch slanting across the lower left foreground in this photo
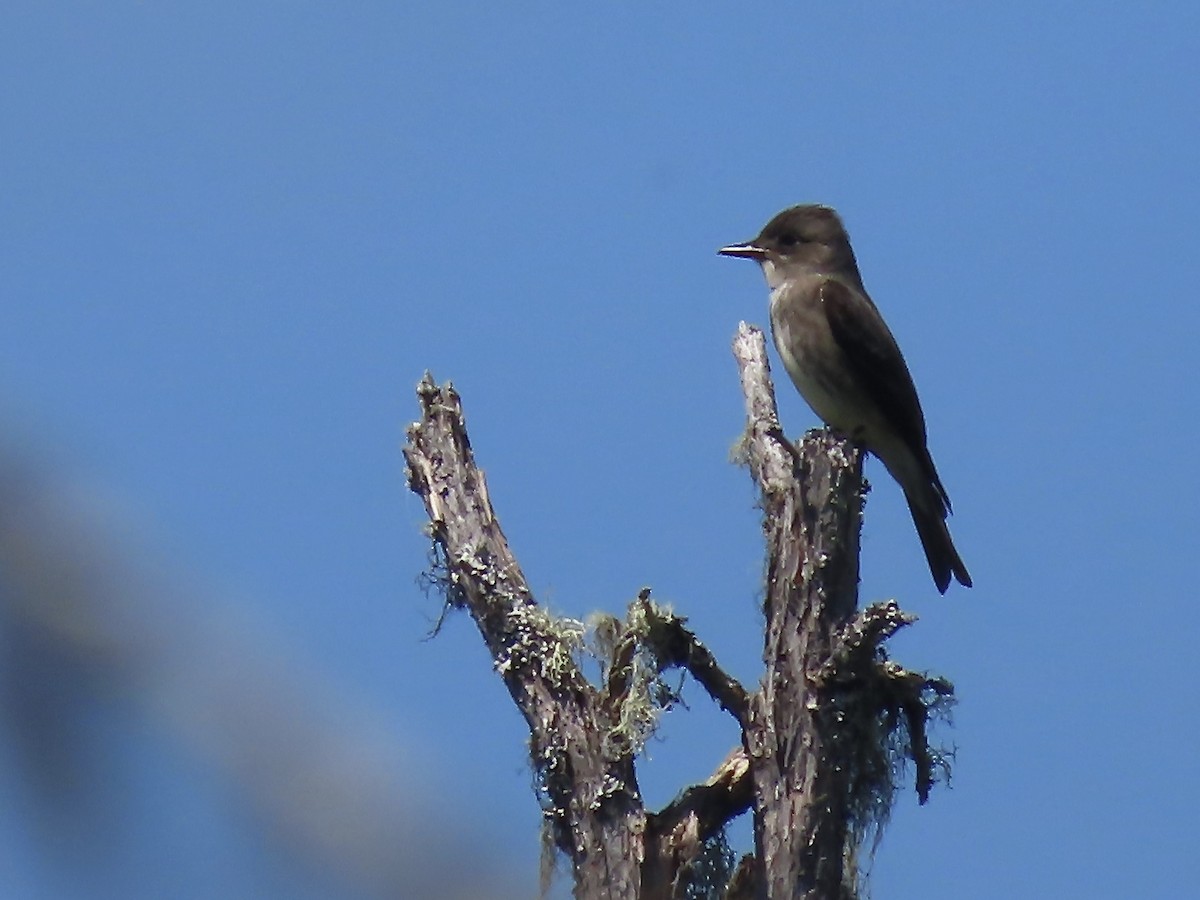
[0,444,516,900]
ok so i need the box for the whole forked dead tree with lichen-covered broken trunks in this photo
[404,325,953,900]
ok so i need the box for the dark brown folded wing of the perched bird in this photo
[821,278,949,506]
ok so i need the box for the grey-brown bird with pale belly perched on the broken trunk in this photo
[718,205,971,594]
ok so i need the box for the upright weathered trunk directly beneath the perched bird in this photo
[736,329,863,900]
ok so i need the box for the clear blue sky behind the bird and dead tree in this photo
[0,2,1200,900]
